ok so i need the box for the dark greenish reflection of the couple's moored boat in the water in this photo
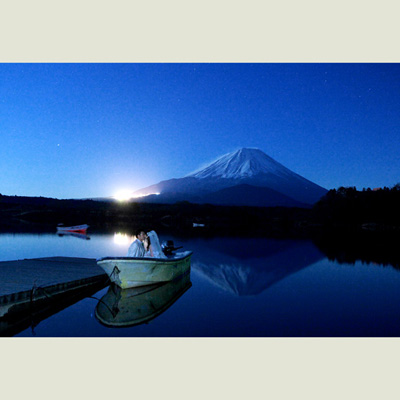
[95,271,192,327]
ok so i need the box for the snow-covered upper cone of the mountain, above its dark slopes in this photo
[188,148,289,179]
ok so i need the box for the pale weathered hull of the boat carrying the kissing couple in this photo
[97,251,193,289]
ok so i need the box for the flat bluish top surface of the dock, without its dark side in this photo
[0,257,105,296]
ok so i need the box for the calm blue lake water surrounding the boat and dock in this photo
[0,230,400,337]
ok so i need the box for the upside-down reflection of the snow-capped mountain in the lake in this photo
[192,238,324,296]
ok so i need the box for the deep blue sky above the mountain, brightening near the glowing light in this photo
[0,64,400,198]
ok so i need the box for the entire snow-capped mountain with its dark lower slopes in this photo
[133,148,327,207]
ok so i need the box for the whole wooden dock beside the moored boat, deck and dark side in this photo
[0,257,109,336]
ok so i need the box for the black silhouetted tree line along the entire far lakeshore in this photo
[0,183,400,236]
